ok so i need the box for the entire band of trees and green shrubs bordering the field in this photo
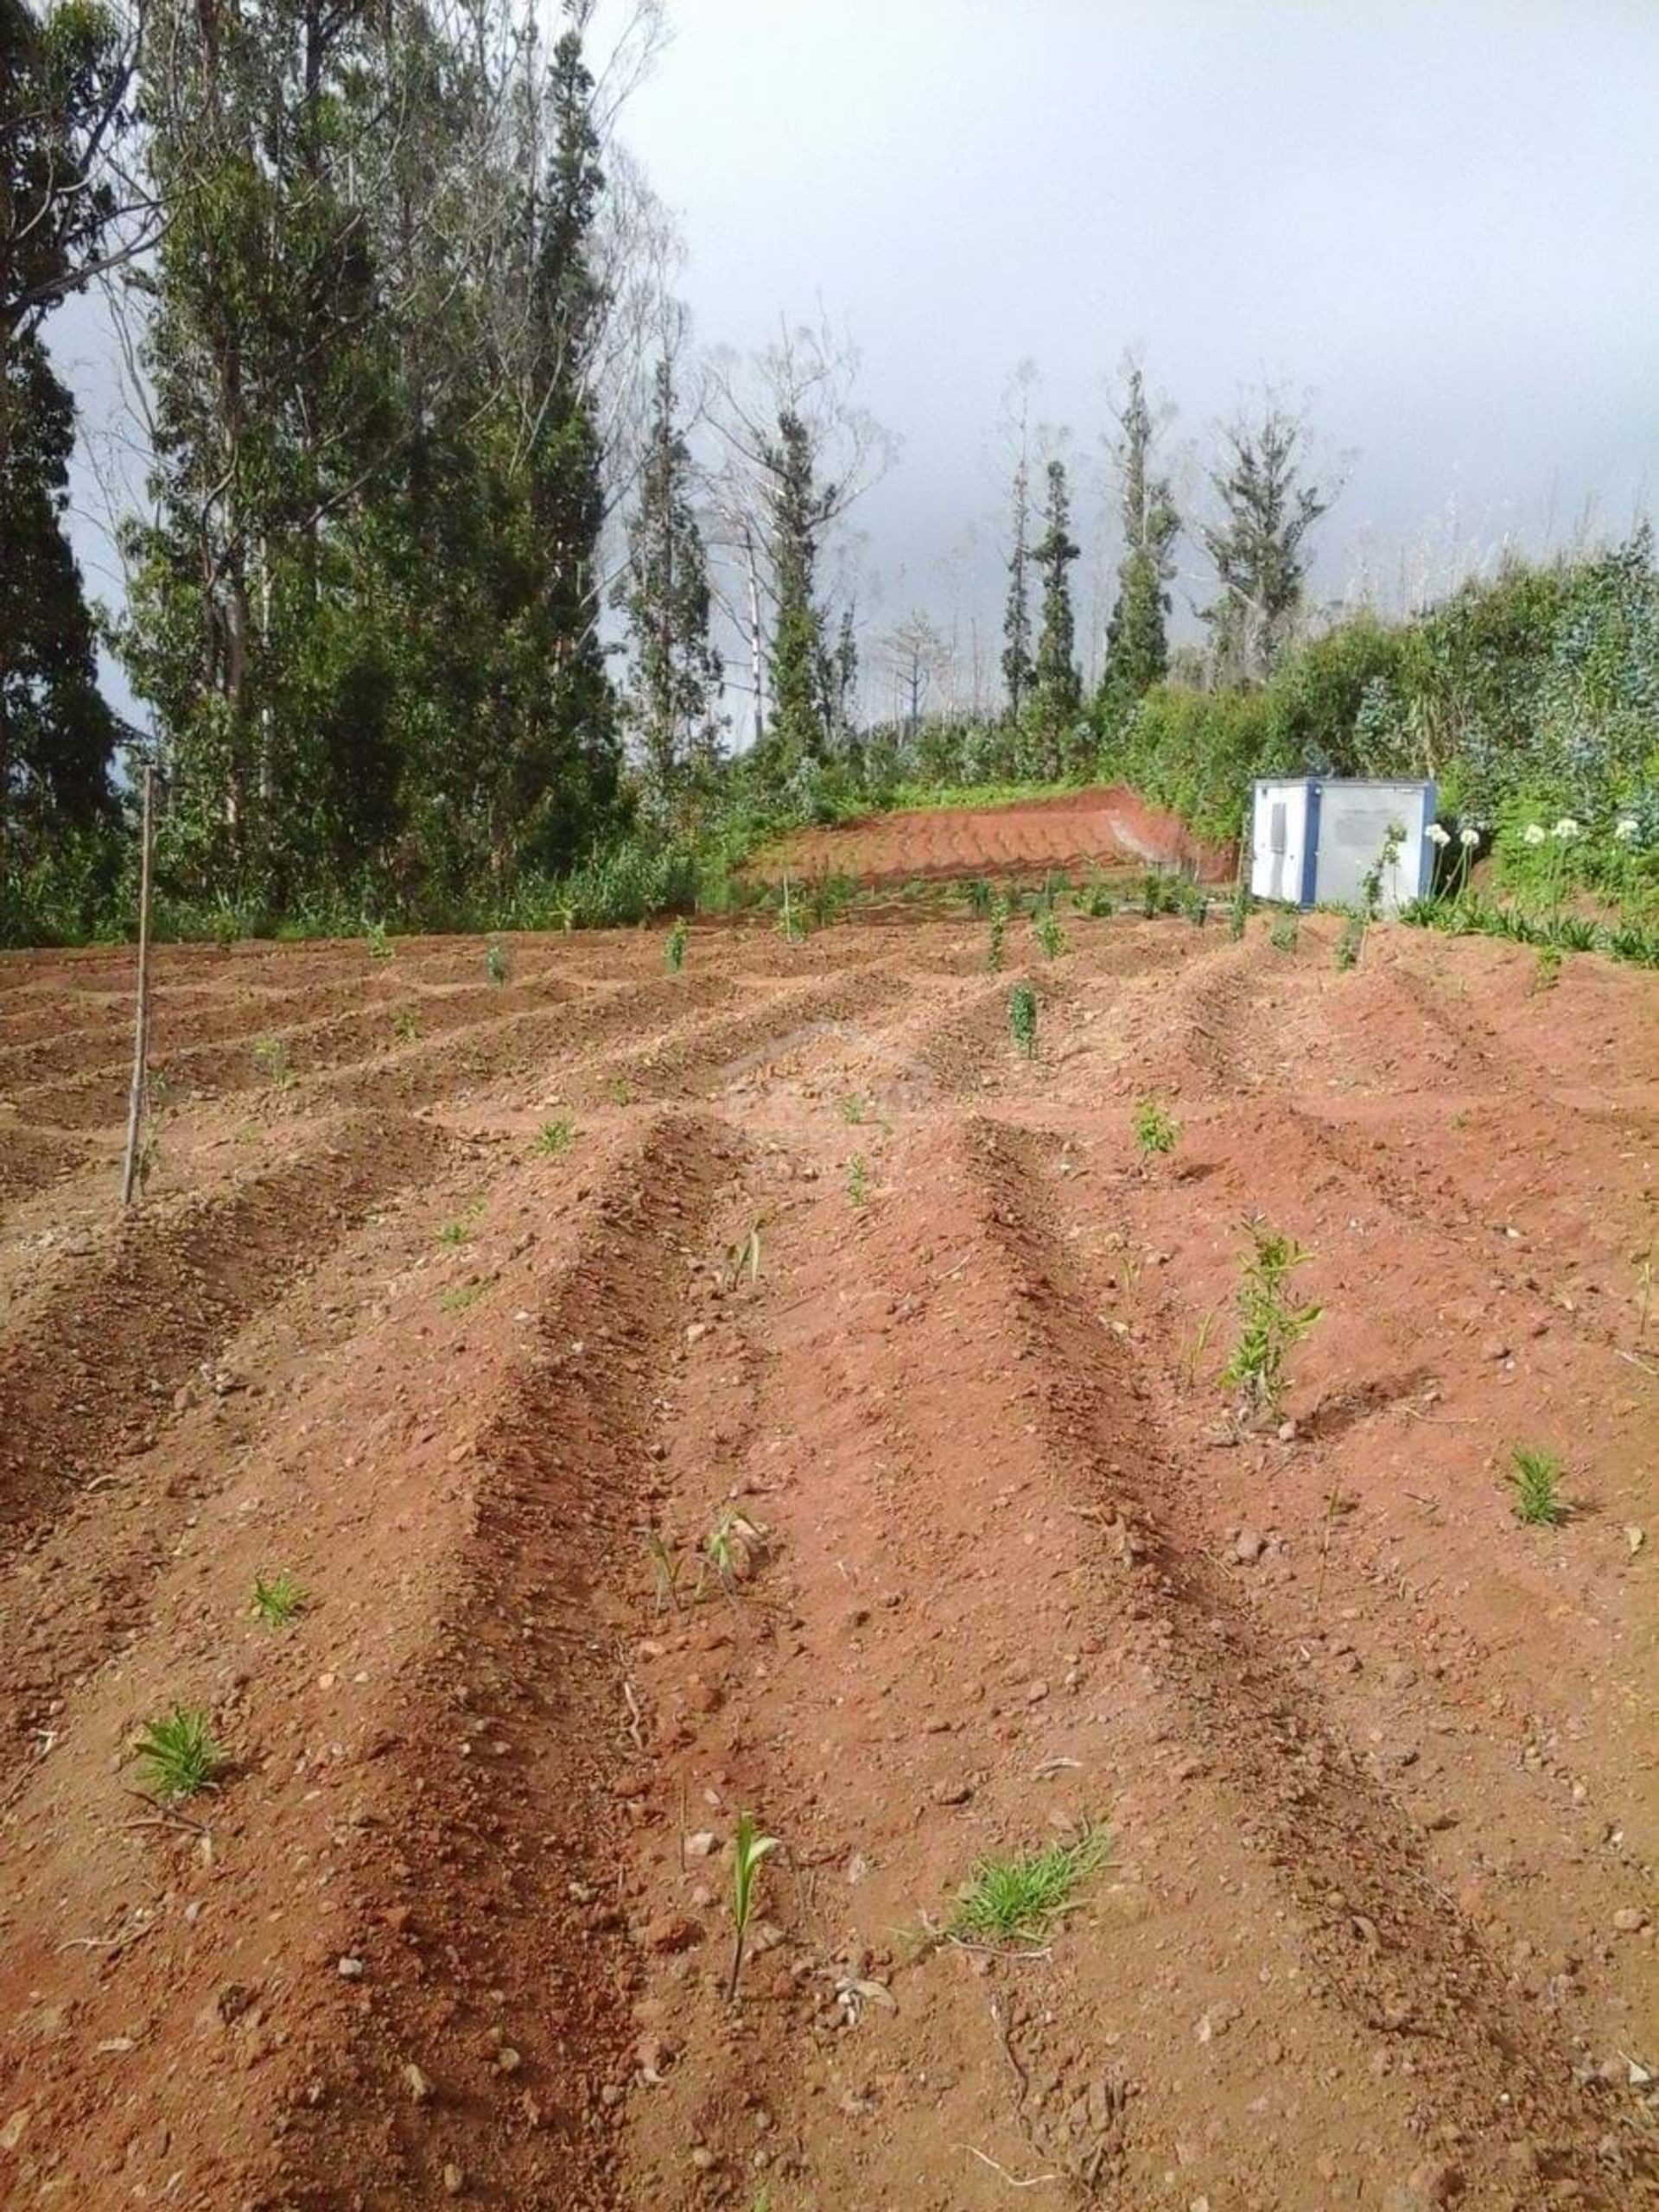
[0,0,1659,938]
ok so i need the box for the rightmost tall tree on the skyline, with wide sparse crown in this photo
[1204,394,1334,679]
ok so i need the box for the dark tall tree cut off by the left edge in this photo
[0,0,130,898]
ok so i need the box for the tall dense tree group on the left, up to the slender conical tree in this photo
[0,0,752,933]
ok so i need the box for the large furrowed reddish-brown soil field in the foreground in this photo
[0,906,1659,2212]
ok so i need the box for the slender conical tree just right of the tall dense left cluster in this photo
[617,360,721,807]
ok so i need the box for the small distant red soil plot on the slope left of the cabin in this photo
[757,783,1234,885]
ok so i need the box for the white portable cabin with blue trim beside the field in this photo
[1249,777,1435,912]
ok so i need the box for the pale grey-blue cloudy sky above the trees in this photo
[53,0,1659,725]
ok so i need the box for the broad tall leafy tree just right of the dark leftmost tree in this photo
[124,0,398,907]
